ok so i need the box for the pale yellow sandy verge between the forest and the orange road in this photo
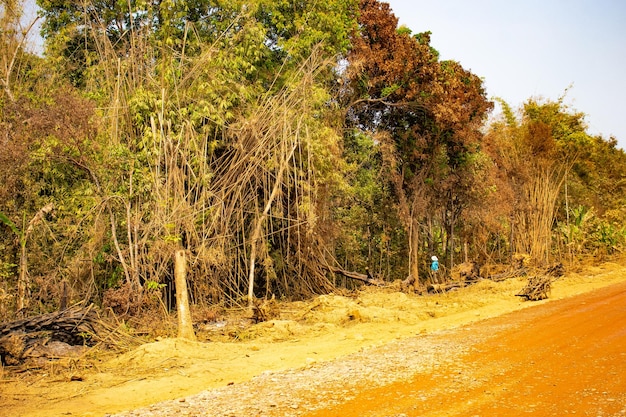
[0,264,626,416]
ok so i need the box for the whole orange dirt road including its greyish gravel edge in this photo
[107,276,626,417]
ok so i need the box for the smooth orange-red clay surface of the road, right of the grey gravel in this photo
[306,284,626,417]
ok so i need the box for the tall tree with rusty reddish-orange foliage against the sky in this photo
[345,0,492,278]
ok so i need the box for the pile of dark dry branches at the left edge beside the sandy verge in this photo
[0,306,99,365]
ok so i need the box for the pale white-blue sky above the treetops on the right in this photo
[385,0,626,150]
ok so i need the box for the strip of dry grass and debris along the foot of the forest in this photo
[2,263,624,388]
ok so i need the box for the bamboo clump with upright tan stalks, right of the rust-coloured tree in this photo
[488,97,592,264]
